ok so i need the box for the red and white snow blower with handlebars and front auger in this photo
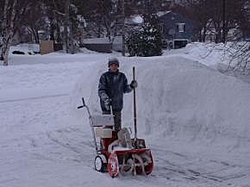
[78,98,154,177]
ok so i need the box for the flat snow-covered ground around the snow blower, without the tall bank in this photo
[0,52,250,187]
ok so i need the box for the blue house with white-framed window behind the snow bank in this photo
[158,11,194,49]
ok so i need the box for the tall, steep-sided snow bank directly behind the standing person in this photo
[72,55,250,151]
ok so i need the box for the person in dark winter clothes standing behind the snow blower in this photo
[98,58,137,131]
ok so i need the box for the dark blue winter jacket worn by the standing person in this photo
[98,71,132,111]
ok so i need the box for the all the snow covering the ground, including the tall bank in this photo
[0,43,250,187]
